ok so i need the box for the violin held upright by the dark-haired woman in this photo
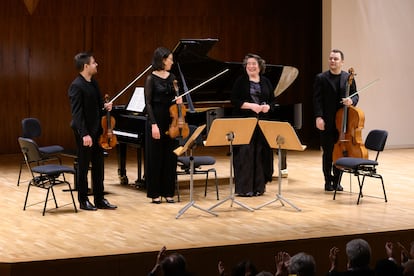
[166,80,190,139]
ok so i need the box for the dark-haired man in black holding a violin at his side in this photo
[68,53,117,211]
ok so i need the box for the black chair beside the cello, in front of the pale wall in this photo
[333,130,388,204]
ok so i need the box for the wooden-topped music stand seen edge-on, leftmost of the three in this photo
[174,124,217,219]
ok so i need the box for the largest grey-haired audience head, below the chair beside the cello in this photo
[346,239,371,269]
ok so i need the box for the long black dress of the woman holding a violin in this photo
[144,74,178,198]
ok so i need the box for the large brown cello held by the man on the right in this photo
[332,68,368,162]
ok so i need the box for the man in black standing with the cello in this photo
[313,49,359,191]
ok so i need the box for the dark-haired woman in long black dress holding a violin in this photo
[144,47,182,203]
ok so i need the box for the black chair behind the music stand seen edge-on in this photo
[176,125,219,201]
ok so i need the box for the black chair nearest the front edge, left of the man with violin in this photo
[18,137,78,215]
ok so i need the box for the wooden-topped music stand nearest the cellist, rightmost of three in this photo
[255,121,306,211]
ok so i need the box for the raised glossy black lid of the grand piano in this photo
[171,38,298,102]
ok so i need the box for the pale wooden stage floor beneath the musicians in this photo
[0,147,414,275]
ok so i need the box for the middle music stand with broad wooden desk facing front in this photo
[205,118,257,211]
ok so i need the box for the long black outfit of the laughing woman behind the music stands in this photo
[232,74,275,196]
